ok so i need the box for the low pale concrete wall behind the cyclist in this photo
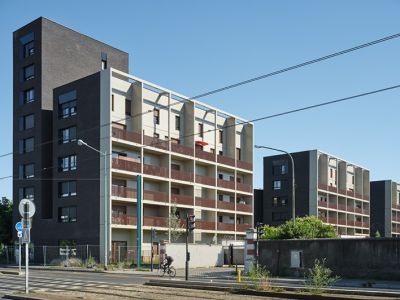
[166,244,224,268]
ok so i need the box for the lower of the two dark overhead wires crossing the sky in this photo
[0,84,400,181]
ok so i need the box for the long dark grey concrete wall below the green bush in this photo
[259,238,400,280]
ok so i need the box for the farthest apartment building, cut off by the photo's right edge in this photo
[371,180,400,237]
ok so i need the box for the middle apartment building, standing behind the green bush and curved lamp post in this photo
[255,150,370,237]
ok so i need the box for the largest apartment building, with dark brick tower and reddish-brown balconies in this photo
[14,18,253,258]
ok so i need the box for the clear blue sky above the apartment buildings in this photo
[0,0,400,197]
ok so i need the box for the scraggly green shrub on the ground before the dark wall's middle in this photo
[306,258,339,294]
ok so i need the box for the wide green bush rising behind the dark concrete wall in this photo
[261,216,337,240]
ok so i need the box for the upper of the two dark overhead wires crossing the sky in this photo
[0,33,400,158]
